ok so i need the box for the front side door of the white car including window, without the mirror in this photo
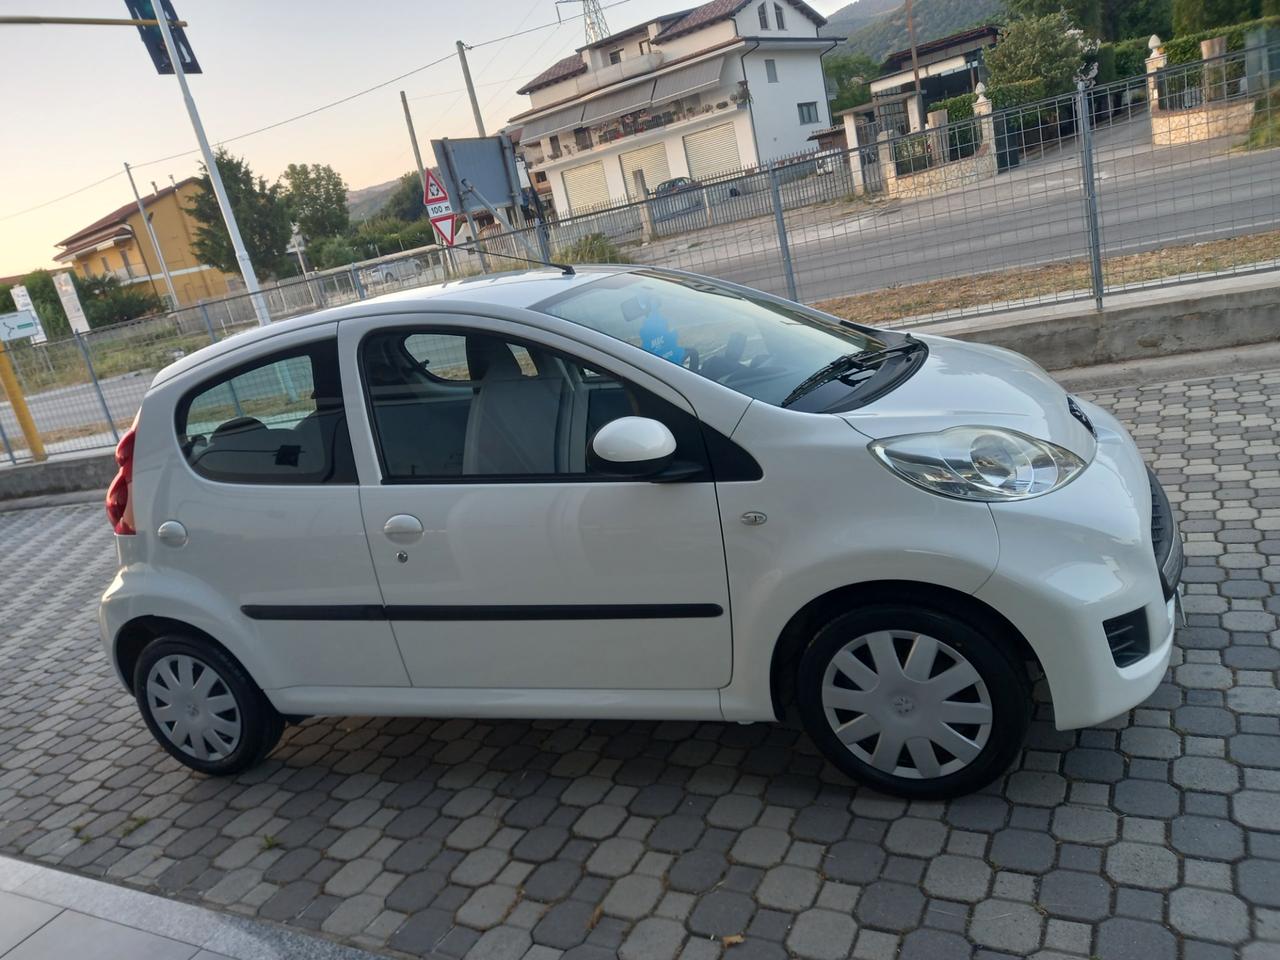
[339,315,732,690]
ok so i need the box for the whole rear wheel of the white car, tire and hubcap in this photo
[133,635,284,776]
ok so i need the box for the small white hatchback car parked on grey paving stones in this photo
[100,266,1181,797]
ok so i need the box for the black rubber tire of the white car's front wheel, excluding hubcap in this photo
[796,602,1032,800]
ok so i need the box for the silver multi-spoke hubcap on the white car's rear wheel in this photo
[147,654,241,760]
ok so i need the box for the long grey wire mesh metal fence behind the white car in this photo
[0,47,1280,462]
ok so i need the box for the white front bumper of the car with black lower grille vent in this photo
[977,404,1183,730]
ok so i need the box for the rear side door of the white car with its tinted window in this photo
[158,324,408,689]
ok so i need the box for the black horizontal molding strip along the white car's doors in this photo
[241,603,724,621]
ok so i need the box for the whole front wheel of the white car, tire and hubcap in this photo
[796,604,1032,799]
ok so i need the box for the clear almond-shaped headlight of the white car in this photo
[868,426,1084,502]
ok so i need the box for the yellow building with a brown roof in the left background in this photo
[54,177,239,306]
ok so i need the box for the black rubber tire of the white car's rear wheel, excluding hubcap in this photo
[133,634,284,777]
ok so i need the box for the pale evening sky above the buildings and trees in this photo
[0,0,846,276]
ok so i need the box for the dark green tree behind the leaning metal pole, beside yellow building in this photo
[188,150,292,276]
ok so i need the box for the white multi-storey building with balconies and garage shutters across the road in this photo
[511,0,838,215]
